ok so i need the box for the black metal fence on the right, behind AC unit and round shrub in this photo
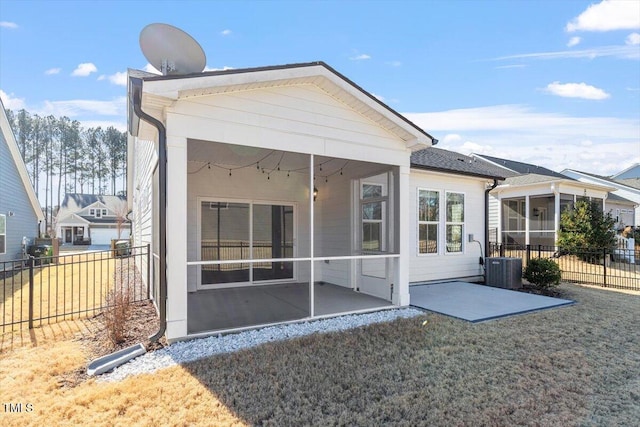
[489,243,640,291]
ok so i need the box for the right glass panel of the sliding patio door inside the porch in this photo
[253,204,293,281]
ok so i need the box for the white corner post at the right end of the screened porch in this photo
[392,166,413,307]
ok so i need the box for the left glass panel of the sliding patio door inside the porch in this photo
[200,202,251,285]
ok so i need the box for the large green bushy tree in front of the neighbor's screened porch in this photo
[558,200,616,258]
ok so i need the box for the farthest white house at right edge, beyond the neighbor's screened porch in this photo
[562,168,640,229]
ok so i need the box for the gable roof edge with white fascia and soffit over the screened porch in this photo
[129,61,438,150]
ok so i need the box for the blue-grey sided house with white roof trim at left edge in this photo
[0,101,44,262]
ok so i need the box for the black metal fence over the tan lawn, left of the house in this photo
[0,245,151,332]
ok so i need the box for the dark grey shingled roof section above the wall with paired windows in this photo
[411,147,505,180]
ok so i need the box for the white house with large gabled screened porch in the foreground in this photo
[128,62,502,341]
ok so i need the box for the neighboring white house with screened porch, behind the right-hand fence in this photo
[472,154,634,246]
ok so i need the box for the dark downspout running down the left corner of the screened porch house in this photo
[131,79,167,343]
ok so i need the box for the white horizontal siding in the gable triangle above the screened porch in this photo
[168,85,409,165]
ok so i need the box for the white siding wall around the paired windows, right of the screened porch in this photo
[409,169,486,283]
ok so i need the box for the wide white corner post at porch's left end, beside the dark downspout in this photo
[166,133,188,340]
